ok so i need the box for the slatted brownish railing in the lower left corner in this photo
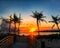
[0,36,14,48]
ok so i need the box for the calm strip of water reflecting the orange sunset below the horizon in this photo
[0,32,59,35]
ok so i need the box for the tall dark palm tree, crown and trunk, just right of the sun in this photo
[32,11,46,35]
